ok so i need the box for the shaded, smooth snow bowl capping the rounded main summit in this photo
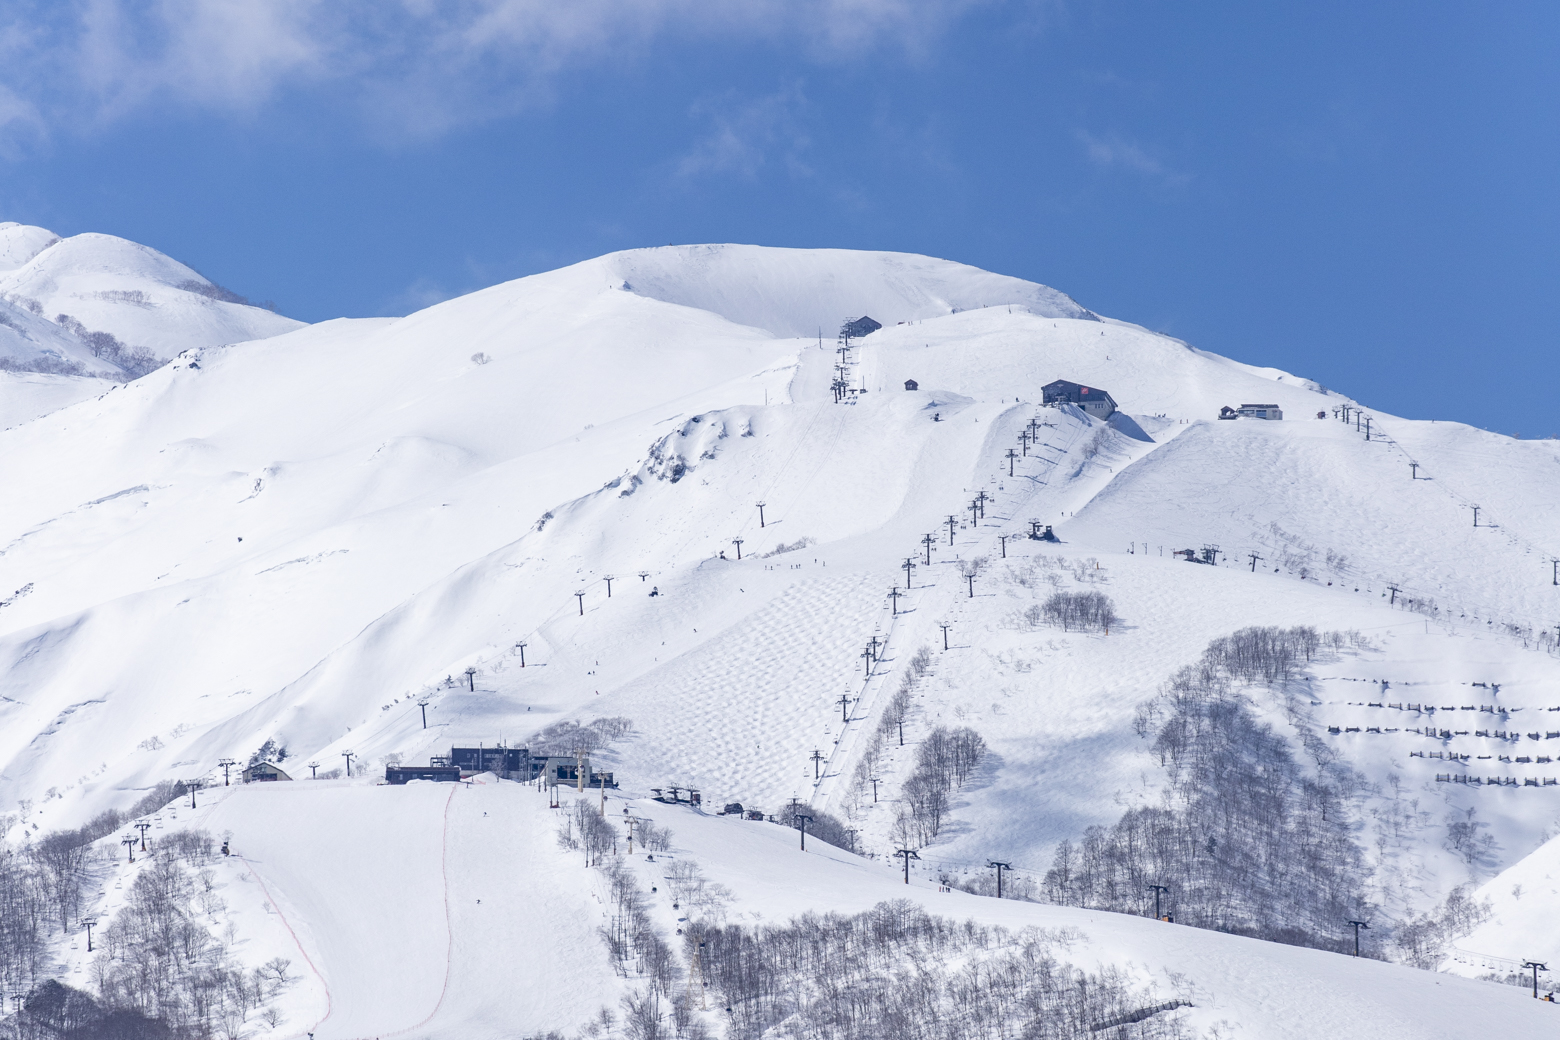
[583,245,1094,340]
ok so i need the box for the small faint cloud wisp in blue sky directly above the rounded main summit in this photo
[677,84,811,178]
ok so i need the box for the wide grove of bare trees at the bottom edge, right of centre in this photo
[685,900,1190,1040]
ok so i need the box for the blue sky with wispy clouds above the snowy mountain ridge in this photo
[0,0,1560,437]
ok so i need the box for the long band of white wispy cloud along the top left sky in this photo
[0,0,985,146]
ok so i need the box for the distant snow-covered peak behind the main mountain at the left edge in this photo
[0,223,303,377]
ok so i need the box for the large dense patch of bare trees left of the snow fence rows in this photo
[1044,628,1371,950]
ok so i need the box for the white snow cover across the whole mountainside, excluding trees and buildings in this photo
[0,241,1560,1040]
